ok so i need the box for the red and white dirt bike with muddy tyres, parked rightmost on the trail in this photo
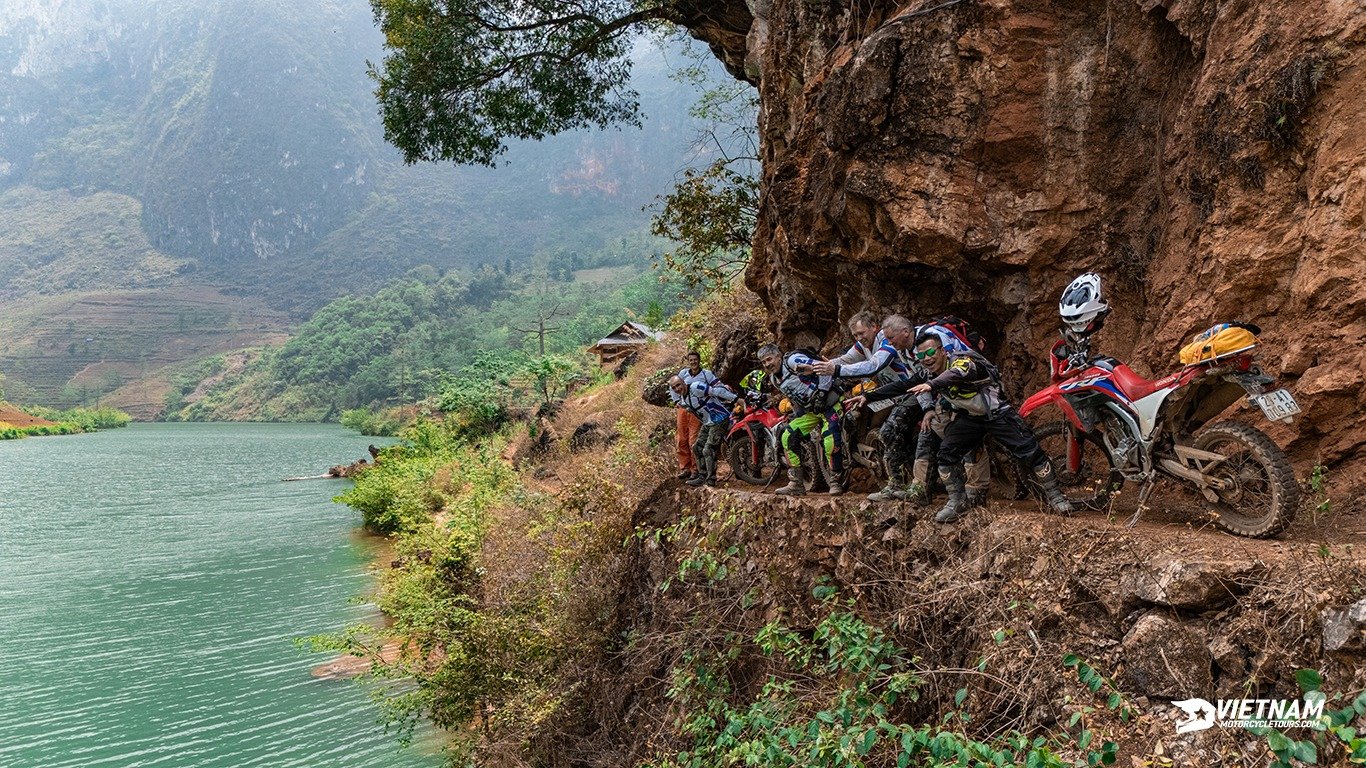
[1020,342,1299,538]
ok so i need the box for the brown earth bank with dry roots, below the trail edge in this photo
[560,481,1366,768]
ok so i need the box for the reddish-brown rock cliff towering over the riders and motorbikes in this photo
[683,0,1366,462]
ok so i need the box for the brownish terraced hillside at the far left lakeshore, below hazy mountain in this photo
[0,286,291,418]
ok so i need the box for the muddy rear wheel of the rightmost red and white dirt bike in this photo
[1194,421,1299,538]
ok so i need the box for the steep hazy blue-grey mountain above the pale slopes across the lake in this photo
[0,0,715,303]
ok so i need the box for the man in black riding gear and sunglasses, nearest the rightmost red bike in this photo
[910,332,1072,522]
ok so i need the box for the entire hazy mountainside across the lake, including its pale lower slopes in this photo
[0,0,726,413]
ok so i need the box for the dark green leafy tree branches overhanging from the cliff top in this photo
[372,0,678,165]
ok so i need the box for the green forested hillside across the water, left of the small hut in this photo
[164,264,684,421]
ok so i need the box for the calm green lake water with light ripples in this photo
[0,424,441,768]
